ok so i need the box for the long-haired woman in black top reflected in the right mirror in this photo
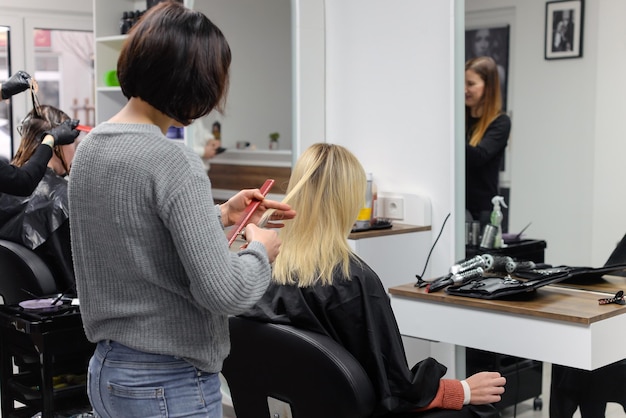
[465,57,511,223]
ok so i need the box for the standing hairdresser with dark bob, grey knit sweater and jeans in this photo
[69,2,295,418]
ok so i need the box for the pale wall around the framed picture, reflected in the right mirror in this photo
[466,0,626,266]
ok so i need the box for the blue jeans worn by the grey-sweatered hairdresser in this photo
[87,341,222,418]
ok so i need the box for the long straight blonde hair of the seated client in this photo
[266,143,366,287]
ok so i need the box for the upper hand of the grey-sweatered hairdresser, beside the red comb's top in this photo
[221,189,296,228]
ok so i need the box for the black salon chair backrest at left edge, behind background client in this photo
[0,240,59,305]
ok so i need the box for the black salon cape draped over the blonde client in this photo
[241,260,446,416]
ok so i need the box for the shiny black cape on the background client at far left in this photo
[0,168,74,296]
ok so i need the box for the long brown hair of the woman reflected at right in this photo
[465,57,502,147]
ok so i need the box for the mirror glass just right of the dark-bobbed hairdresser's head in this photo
[194,0,293,150]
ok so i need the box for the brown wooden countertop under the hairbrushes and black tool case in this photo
[389,278,626,325]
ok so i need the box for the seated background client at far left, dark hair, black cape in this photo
[0,105,78,296]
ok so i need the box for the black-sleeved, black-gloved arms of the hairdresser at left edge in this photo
[0,71,79,196]
